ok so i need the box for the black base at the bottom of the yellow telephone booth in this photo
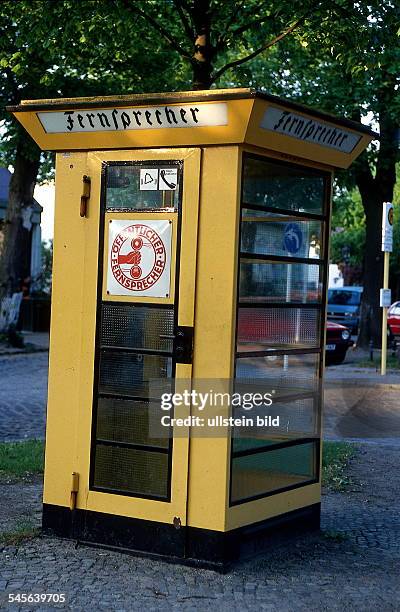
[43,504,321,571]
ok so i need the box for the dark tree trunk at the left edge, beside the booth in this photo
[0,142,40,299]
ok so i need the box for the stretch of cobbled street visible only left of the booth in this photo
[0,352,48,441]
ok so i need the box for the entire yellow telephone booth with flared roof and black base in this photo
[9,89,375,567]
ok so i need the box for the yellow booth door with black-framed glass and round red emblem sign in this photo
[80,149,200,540]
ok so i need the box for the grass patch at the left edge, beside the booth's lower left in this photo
[0,440,44,478]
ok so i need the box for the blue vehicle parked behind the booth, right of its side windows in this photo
[327,287,363,334]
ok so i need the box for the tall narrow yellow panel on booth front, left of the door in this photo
[44,153,90,506]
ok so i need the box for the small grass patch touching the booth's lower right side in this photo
[322,442,357,491]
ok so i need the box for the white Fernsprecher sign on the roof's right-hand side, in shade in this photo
[260,106,361,153]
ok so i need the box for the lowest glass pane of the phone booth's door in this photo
[93,444,168,498]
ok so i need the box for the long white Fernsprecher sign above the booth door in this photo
[36,102,228,134]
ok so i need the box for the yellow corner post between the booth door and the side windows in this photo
[188,147,240,531]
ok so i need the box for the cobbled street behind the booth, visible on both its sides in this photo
[0,353,400,445]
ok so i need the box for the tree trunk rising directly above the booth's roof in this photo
[192,0,215,90]
